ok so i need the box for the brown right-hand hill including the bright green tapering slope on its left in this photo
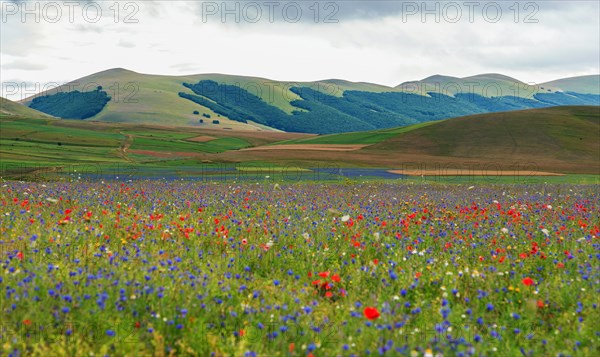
[276,106,600,154]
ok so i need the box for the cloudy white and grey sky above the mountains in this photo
[0,0,600,99]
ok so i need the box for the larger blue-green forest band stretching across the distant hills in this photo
[179,80,600,134]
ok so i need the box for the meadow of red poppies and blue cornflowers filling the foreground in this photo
[0,180,600,356]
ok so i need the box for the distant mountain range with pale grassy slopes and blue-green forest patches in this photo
[18,69,600,134]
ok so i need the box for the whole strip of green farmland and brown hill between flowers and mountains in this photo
[0,106,600,175]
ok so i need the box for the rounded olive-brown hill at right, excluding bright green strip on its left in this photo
[364,107,600,165]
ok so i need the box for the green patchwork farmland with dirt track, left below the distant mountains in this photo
[0,112,306,170]
